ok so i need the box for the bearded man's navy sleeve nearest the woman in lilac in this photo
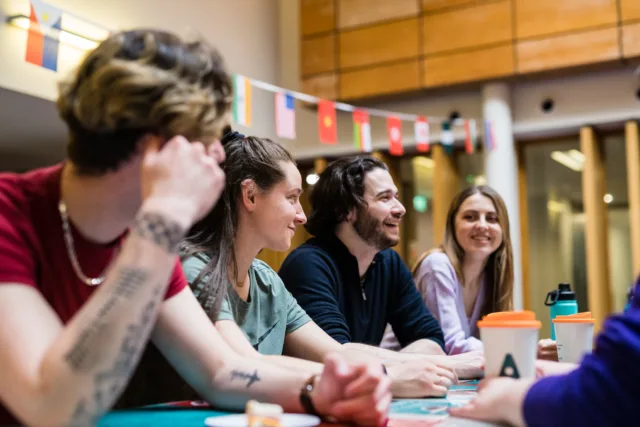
[389,251,444,351]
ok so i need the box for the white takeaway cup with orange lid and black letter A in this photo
[478,310,542,378]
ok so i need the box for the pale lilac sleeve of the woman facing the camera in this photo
[417,253,484,354]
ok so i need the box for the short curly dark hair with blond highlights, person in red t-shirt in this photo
[57,29,233,175]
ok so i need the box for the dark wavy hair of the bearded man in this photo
[305,156,389,237]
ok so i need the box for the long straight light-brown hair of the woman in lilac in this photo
[412,185,513,315]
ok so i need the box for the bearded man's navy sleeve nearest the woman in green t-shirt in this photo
[278,247,351,344]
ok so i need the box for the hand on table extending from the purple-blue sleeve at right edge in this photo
[449,378,534,427]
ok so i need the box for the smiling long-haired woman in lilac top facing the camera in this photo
[384,185,513,354]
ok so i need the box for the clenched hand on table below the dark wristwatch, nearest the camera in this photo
[312,354,392,426]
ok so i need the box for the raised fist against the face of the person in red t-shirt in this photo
[141,136,225,226]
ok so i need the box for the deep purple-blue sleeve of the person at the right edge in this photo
[523,309,640,427]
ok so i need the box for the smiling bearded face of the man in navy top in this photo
[351,168,406,250]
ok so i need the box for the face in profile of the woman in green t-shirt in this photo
[252,162,307,252]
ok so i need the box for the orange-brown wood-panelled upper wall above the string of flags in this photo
[299,0,640,100]
